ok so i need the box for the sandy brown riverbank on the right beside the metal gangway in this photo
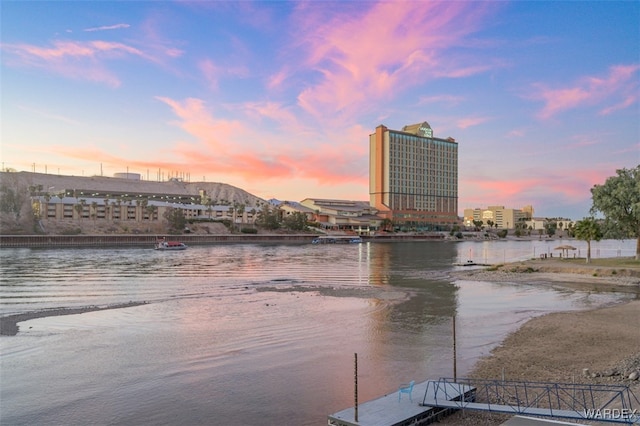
[441,259,640,425]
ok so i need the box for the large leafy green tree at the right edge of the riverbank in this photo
[591,166,640,260]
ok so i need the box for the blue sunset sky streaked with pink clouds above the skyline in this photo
[0,1,640,220]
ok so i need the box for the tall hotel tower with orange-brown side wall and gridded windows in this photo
[369,121,458,230]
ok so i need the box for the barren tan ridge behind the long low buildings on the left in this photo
[0,172,266,207]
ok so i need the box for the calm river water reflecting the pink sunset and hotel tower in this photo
[0,241,635,425]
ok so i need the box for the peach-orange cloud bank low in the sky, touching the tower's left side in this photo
[148,97,368,185]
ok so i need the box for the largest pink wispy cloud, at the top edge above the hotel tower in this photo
[295,2,495,121]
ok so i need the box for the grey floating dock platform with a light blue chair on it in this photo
[328,380,475,426]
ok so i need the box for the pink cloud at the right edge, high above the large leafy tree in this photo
[535,65,640,119]
